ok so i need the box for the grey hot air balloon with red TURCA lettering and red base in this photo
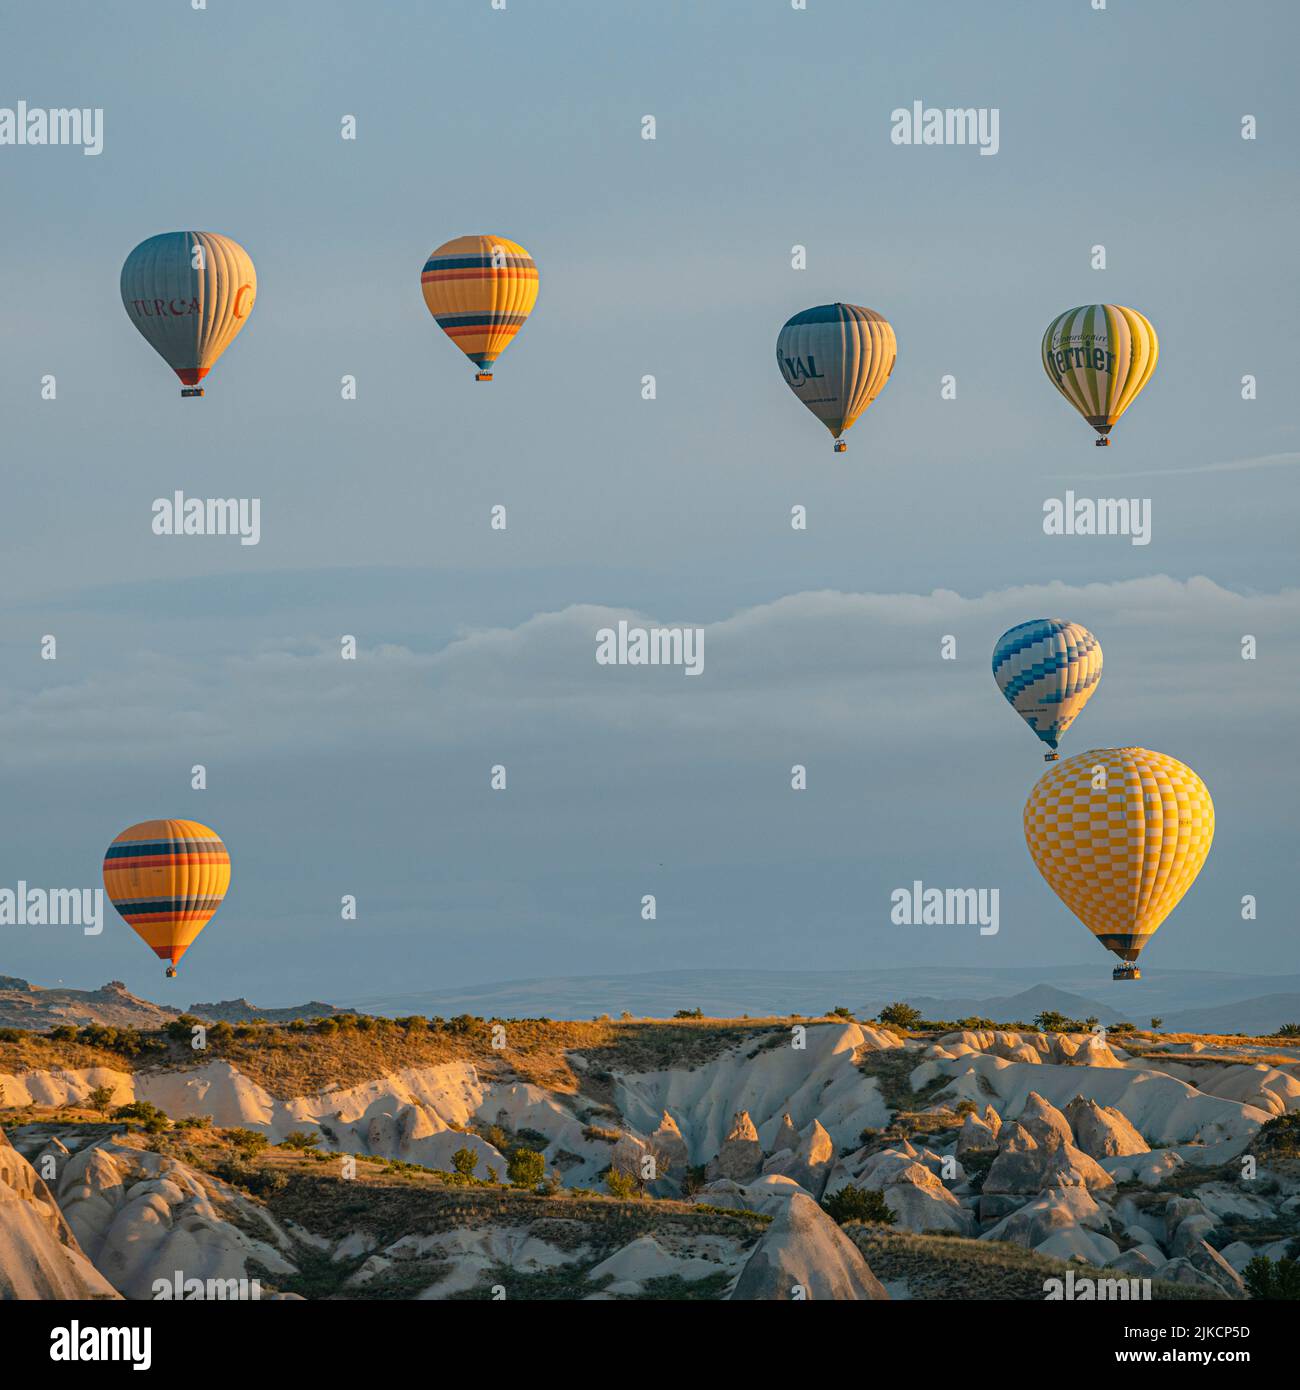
[122,232,257,396]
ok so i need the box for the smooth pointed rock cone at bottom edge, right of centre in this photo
[730,1194,888,1301]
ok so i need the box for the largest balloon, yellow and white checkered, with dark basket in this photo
[1025,748,1214,980]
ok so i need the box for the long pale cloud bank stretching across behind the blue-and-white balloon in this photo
[0,575,1300,767]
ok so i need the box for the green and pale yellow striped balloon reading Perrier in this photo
[1043,304,1160,448]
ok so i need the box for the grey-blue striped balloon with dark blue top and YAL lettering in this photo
[776,304,898,453]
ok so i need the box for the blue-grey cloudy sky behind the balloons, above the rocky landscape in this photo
[0,0,1300,1004]
